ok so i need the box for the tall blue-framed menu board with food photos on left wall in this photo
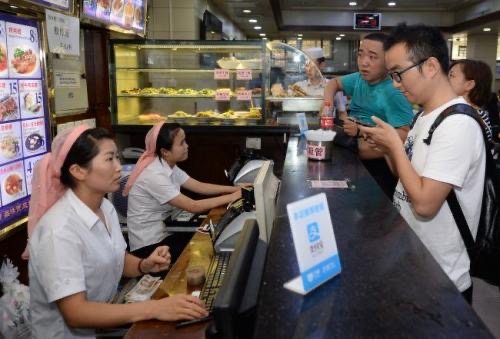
[0,14,49,234]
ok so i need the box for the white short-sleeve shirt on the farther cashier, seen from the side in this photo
[127,158,189,251]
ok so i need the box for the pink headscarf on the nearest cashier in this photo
[22,125,89,259]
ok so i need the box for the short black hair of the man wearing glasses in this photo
[384,23,450,74]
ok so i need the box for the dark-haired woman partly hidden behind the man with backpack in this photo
[448,59,499,141]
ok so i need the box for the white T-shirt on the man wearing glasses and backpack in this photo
[394,97,486,291]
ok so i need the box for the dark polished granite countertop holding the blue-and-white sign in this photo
[255,138,492,339]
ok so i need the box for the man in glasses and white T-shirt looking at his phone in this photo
[361,24,486,303]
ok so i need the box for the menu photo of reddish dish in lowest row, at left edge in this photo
[0,161,27,206]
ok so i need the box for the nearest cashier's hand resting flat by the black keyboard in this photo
[153,294,208,321]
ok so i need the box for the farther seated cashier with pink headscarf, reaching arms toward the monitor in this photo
[124,122,241,263]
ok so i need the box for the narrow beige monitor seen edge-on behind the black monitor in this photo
[253,160,280,244]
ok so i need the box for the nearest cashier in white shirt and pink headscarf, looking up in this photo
[25,126,208,339]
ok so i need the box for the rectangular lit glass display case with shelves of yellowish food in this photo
[109,40,269,125]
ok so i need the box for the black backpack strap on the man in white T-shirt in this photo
[423,104,492,252]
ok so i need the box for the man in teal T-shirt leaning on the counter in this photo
[324,33,413,199]
